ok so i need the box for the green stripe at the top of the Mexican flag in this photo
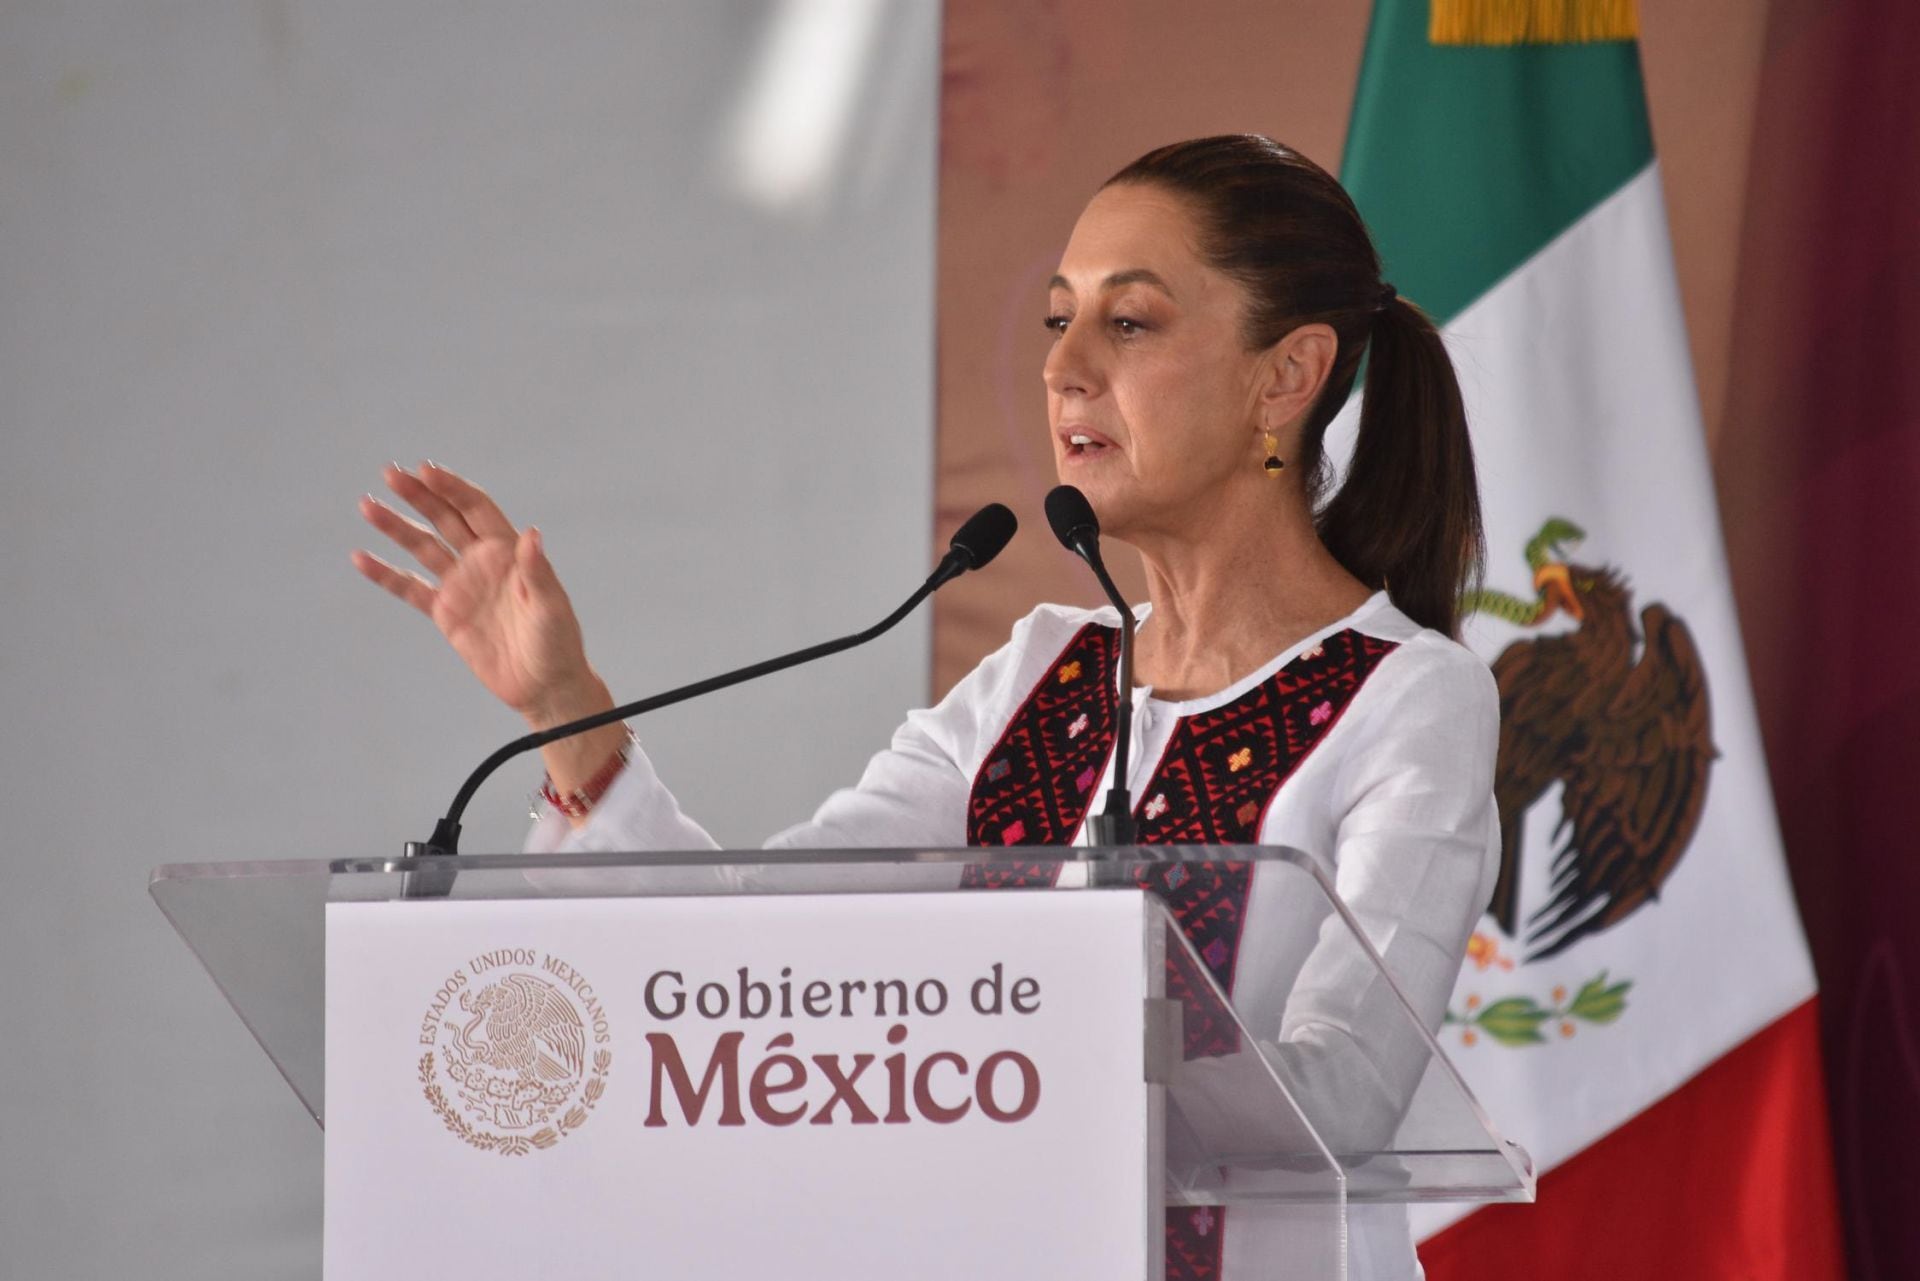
[1340,0,1653,325]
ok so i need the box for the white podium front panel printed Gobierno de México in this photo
[324,893,1162,1281]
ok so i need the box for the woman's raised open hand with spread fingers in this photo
[353,463,611,737]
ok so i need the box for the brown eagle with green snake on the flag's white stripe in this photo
[1463,517,1718,960]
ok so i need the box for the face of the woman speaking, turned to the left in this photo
[1043,186,1271,538]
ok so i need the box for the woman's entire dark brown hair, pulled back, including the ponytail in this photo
[1106,134,1484,636]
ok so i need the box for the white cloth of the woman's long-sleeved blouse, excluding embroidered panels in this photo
[528,592,1500,1281]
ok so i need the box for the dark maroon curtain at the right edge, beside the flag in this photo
[1716,0,1920,1281]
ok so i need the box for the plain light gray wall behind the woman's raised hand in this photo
[0,0,939,1277]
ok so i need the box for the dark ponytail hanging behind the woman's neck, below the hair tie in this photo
[1317,298,1486,636]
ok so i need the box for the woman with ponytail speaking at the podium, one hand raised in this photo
[355,136,1500,1277]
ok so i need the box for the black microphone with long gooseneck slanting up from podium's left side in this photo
[403,503,1020,860]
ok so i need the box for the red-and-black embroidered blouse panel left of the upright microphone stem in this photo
[966,622,1119,845]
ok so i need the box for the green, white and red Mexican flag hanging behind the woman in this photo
[1340,0,1843,1281]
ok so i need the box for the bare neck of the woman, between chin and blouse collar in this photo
[1133,505,1373,699]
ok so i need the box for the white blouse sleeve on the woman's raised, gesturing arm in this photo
[526,611,1039,853]
